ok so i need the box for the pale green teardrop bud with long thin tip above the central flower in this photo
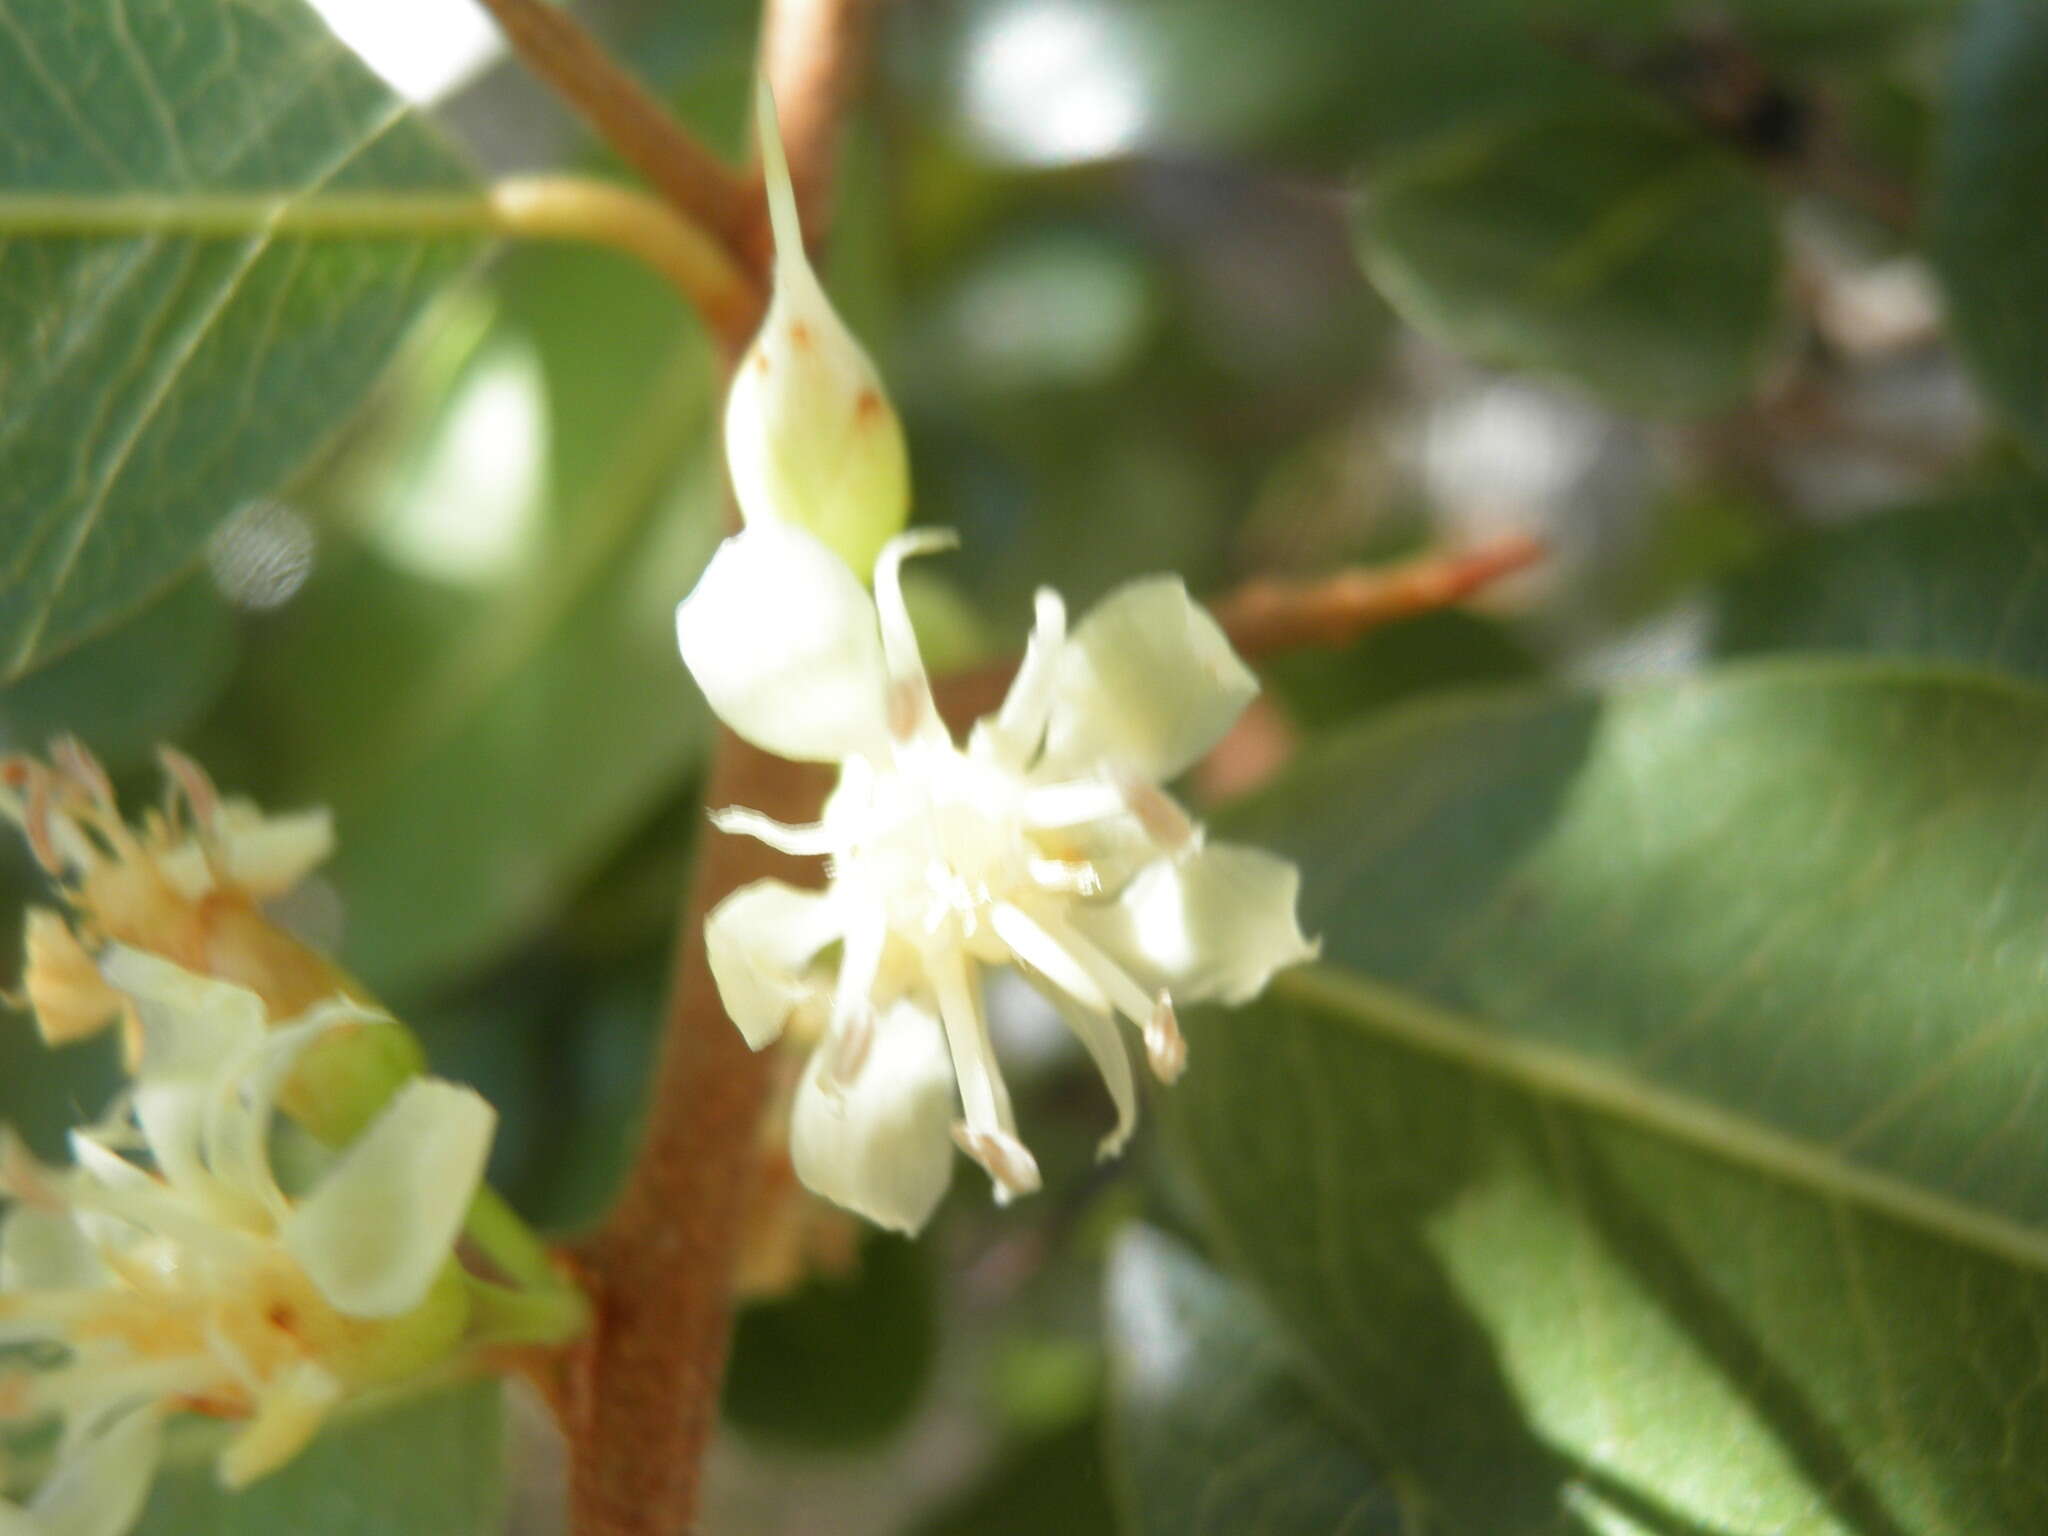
[725,86,909,575]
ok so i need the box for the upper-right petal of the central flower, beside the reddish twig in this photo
[1044,575,1260,782]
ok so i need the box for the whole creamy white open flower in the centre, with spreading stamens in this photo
[676,522,1315,1231]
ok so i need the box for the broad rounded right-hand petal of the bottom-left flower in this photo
[283,1079,498,1317]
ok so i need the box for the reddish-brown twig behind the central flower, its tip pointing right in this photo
[934,535,1544,731]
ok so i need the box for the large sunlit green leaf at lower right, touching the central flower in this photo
[1169,664,2048,1536]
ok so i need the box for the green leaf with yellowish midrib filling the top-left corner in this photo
[0,0,479,678]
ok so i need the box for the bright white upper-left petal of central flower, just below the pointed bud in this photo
[676,522,889,762]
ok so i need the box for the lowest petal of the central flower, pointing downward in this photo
[788,999,954,1233]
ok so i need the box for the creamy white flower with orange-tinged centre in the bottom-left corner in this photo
[0,946,496,1536]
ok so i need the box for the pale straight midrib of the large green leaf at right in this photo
[1272,965,2048,1272]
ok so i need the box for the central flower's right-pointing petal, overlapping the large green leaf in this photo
[1071,844,1319,1006]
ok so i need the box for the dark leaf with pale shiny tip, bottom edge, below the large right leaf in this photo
[1108,1227,1411,1536]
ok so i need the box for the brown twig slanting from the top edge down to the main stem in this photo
[483,0,762,280]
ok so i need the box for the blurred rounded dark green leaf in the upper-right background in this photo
[1358,93,1780,412]
